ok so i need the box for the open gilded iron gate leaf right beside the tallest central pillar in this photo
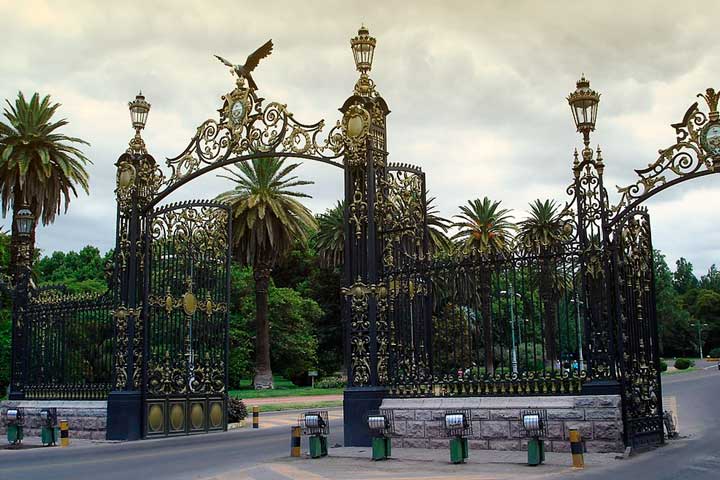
[378,164,432,393]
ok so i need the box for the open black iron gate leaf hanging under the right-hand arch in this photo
[613,208,663,447]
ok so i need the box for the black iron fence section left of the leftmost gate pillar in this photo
[13,291,114,400]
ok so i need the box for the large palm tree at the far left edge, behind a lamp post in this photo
[0,92,92,281]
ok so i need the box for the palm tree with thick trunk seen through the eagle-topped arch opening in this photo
[217,158,317,388]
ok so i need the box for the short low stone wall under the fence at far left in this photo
[0,400,107,440]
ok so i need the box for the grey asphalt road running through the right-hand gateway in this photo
[567,363,720,480]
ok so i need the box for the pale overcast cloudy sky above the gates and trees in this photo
[0,0,720,274]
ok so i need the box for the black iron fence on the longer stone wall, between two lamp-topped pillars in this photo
[380,245,588,396]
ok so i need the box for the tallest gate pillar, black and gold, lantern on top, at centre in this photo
[340,27,390,446]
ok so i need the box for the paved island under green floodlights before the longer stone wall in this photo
[211,448,621,480]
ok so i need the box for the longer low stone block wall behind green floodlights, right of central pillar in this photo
[381,395,624,453]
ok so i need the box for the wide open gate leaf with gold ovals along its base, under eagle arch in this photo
[142,201,231,437]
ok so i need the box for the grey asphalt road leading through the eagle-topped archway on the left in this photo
[0,413,343,480]
